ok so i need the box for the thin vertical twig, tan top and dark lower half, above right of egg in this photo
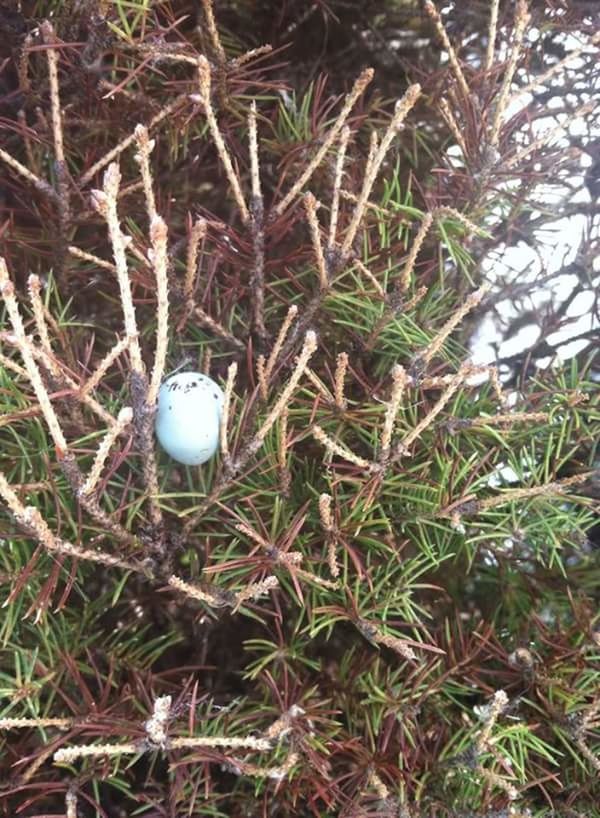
[248,100,267,343]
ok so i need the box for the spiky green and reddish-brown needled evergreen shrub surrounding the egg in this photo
[0,0,600,818]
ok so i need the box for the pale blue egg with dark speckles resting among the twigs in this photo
[156,372,224,466]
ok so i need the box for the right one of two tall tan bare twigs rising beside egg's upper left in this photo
[146,216,169,407]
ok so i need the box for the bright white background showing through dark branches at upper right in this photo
[464,29,600,366]
